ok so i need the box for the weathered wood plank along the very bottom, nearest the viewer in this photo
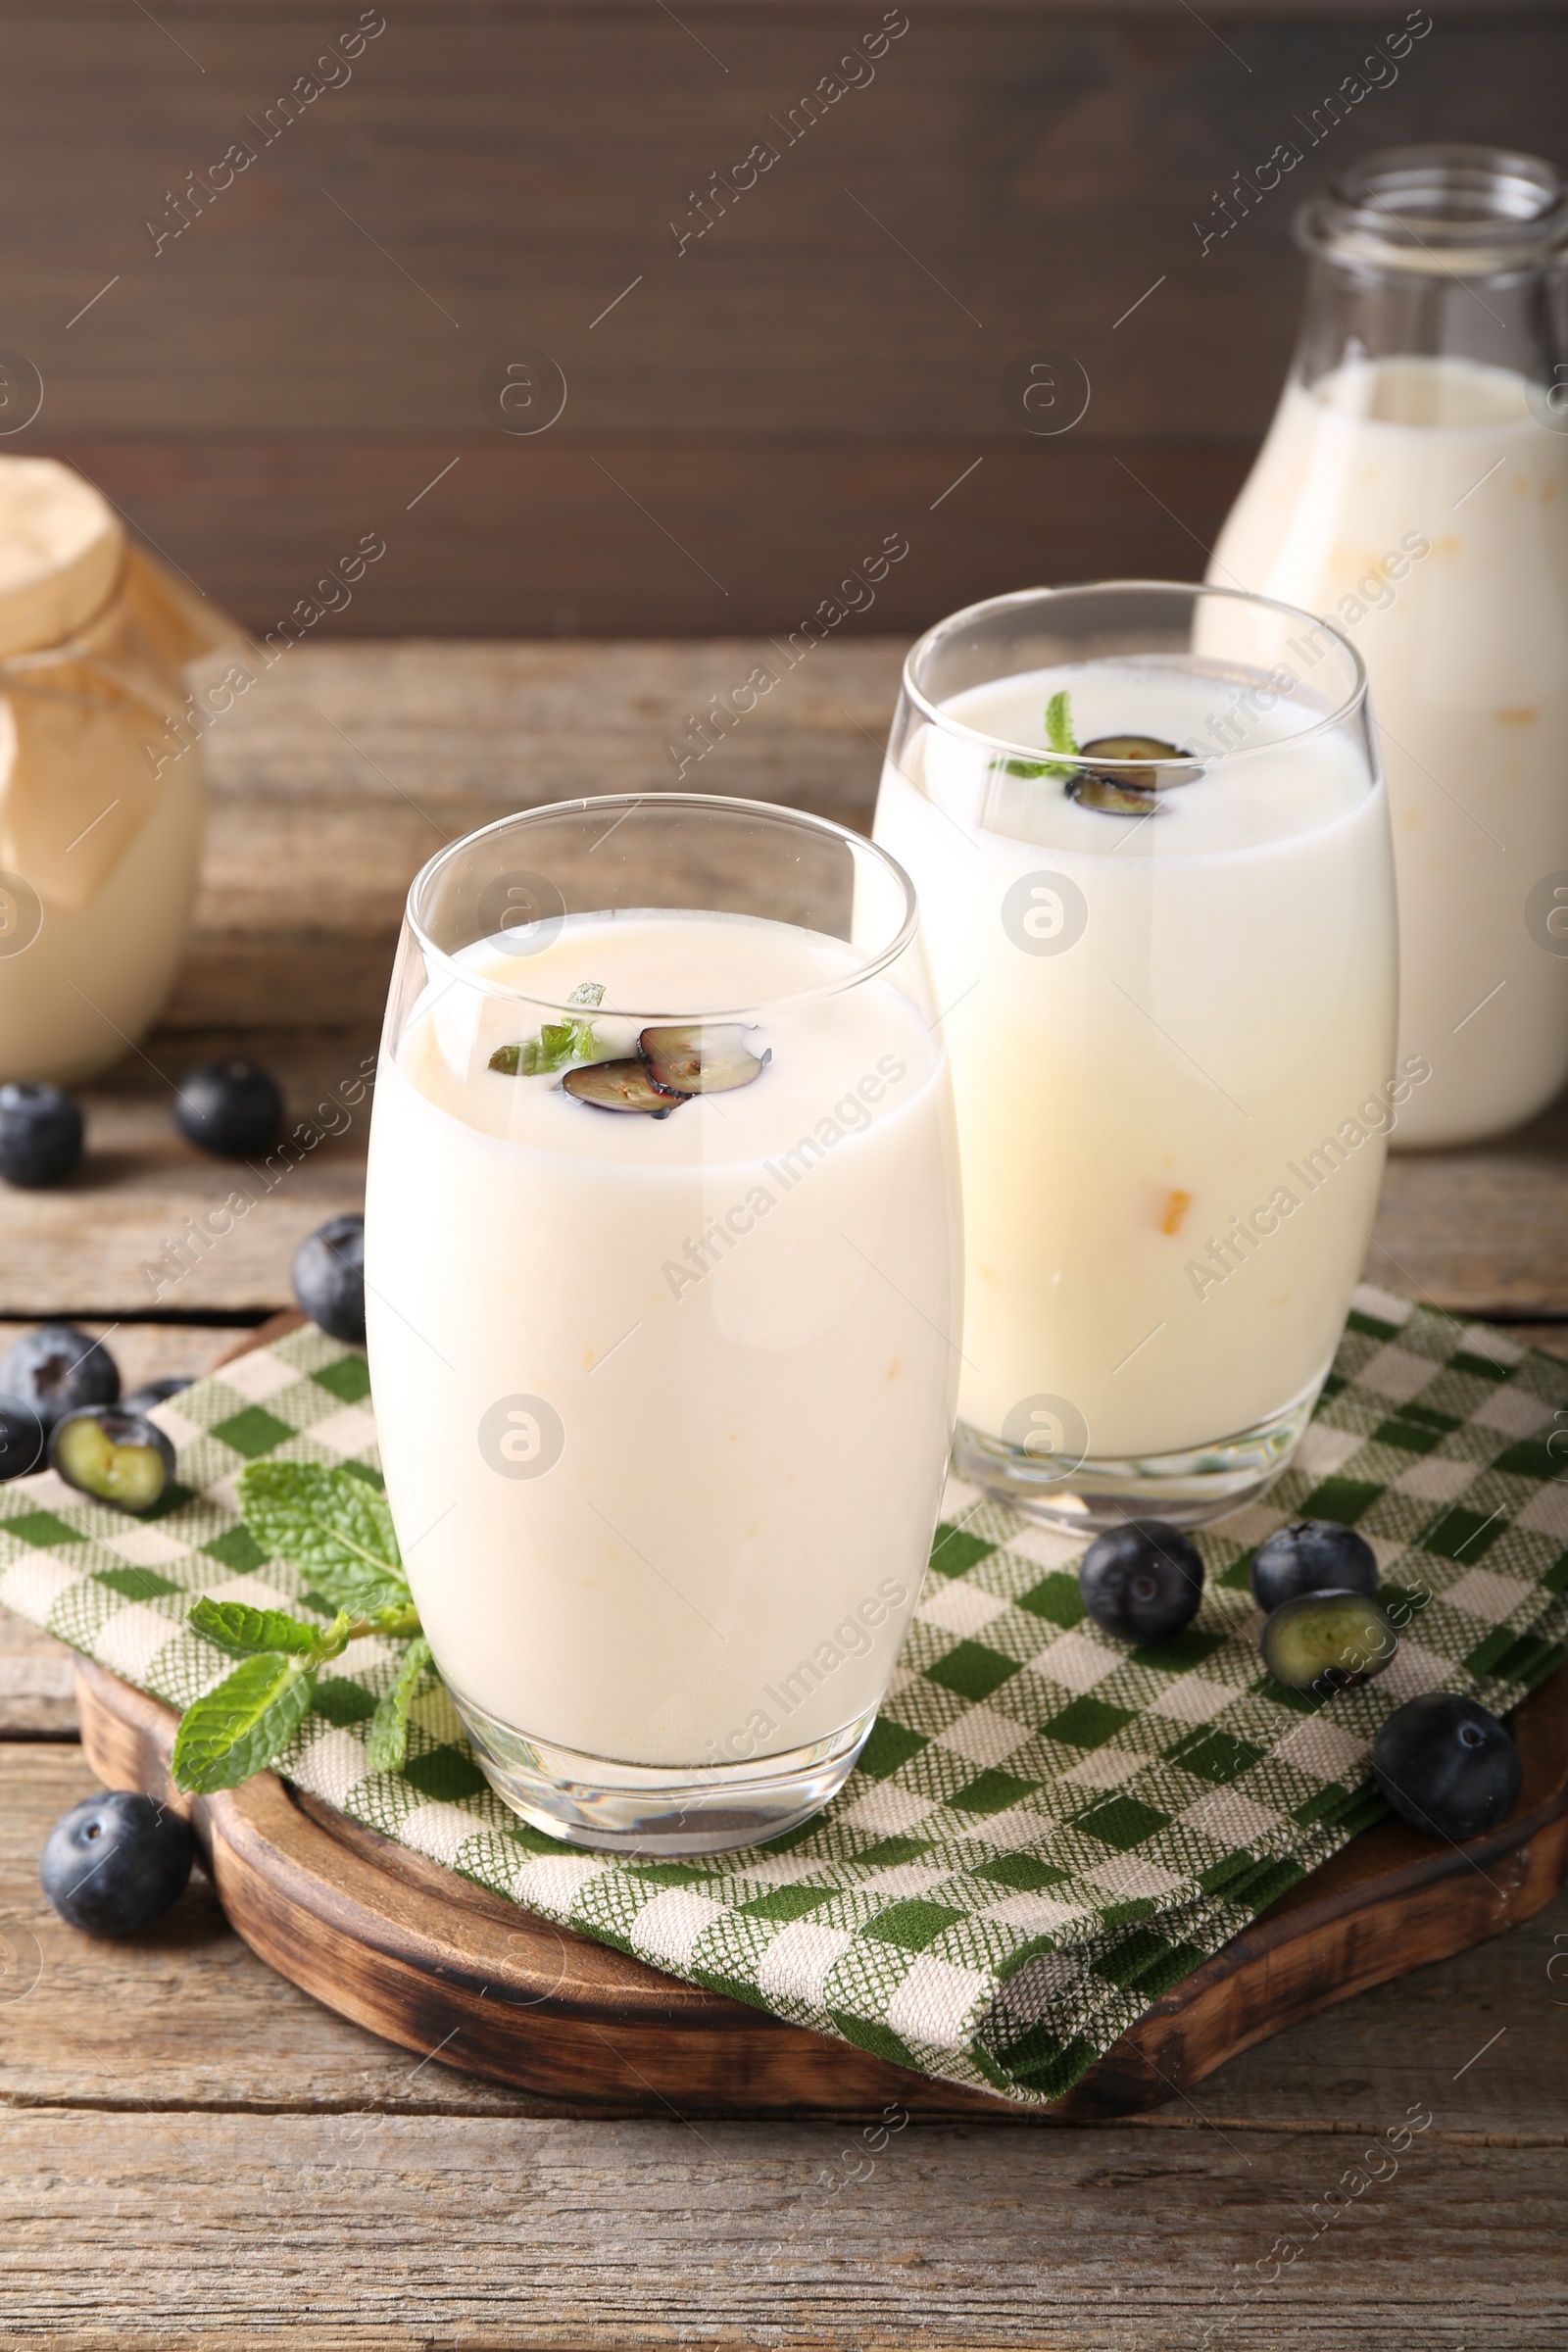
[0,2112,1568,2352]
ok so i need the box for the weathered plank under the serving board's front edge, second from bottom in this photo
[0,1742,1568,2142]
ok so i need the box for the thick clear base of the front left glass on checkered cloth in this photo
[454,1693,877,1856]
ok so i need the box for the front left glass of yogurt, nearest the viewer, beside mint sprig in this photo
[365,793,961,1853]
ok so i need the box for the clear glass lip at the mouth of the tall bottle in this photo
[1296,146,1568,277]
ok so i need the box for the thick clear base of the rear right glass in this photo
[953,1381,1324,1536]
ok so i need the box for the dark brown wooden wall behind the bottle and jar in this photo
[0,0,1568,640]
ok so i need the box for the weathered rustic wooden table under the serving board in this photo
[0,640,1568,2352]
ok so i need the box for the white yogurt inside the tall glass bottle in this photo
[1210,358,1568,1143]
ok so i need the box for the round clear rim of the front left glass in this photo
[405,790,919,1021]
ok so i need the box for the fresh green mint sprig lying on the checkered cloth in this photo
[172,1463,430,1797]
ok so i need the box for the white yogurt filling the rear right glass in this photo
[874,661,1408,1460]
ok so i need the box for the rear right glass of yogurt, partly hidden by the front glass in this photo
[874,581,1400,1531]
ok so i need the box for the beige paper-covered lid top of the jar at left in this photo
[0,457,124,659]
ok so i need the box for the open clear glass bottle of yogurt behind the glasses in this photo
[1208,146,1568,1146]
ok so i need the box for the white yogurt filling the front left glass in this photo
[367,912,959,1766]
